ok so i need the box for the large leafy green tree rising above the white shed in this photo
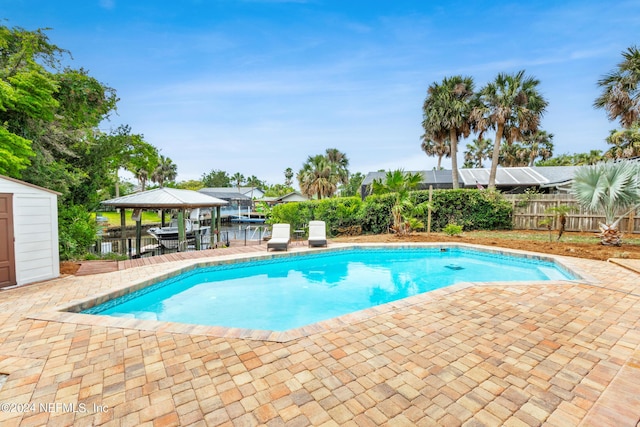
[0,26,117,204]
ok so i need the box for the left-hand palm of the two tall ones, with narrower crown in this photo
[422,76,473,188]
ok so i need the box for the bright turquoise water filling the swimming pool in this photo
[83,248,574,331]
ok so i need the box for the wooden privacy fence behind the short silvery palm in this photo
[504,194,640,233]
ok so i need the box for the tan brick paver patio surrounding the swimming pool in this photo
[0,245,640,427]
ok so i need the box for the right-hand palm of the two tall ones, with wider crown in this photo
[472,70,548,188]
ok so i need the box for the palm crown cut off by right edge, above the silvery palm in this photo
[593,46,640,128]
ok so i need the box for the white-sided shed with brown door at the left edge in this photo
[0,175,60,288]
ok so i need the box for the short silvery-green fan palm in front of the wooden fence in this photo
[571,160,640,246]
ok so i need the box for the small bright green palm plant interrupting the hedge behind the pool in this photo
[371,169,432,235]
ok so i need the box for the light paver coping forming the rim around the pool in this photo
[27,242,598,343]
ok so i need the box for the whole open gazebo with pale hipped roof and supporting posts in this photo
[102,188,227,254]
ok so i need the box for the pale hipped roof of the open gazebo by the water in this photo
[102,188,227,208]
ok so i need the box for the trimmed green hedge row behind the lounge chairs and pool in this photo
[269,189,512,236]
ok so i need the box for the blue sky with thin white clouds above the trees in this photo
[0,0,640,184]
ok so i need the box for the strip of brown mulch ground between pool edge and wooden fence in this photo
[332,230,640,261]
